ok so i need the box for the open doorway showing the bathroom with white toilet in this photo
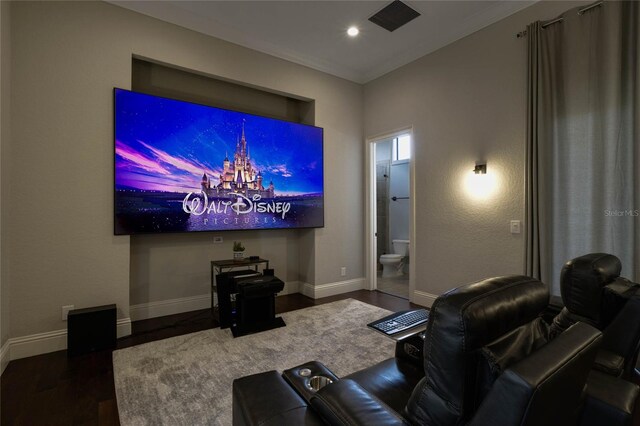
[367,129,415,300]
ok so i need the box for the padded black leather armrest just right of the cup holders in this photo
[311,379,408,425]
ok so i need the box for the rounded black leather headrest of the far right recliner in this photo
[560,253,622,323]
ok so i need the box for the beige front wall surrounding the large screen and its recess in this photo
[3,2,364,336]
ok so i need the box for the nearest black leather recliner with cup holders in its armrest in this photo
[233,276,601,426]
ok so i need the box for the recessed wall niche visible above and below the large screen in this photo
[129,58,315,310]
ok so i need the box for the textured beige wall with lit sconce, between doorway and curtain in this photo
[364,2,582,294]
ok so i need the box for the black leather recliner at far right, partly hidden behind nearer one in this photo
[550,253,640,426]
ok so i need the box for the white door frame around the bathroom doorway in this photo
[365,126,416,302]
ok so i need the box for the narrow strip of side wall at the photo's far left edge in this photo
[0,2,11,347]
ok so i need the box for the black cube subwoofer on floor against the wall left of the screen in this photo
[67,305,117,356]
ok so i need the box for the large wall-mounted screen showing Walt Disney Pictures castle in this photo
[114,89,324,234]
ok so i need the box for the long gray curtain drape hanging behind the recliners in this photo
[525,1,640,294]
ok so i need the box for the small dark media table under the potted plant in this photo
[211,258,269,328]
